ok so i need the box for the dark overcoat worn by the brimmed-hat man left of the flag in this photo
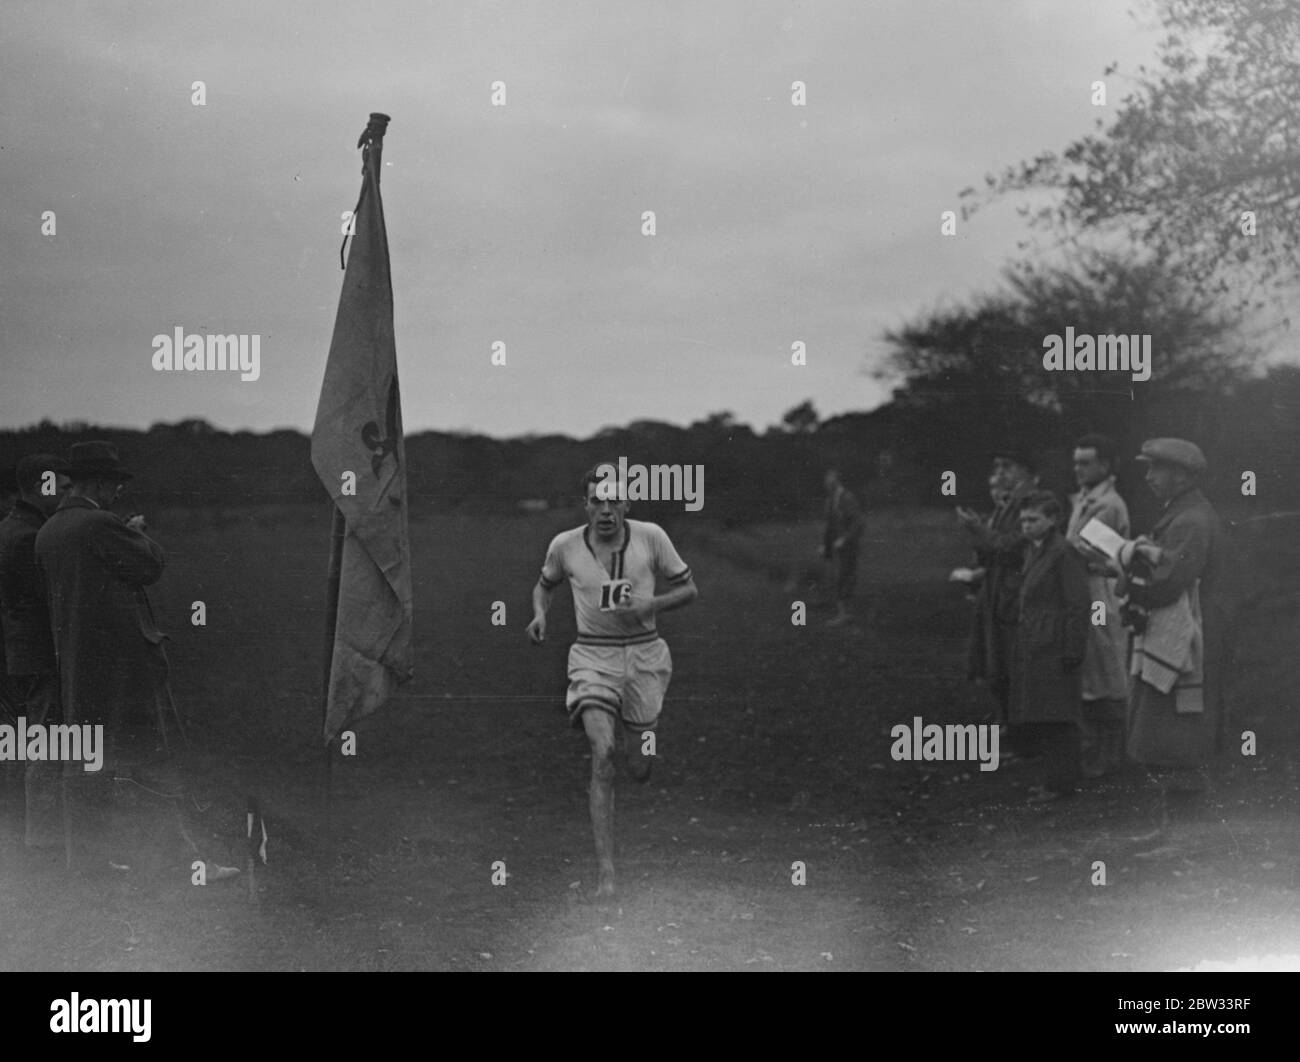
[36,497,166,738]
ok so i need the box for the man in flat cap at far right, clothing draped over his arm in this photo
[1117,438,1231,836]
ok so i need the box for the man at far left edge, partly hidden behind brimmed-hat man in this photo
[0,454,69,848]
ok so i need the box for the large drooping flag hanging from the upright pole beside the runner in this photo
[312,114,411,742]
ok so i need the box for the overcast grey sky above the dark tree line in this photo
[0,0,1190,435]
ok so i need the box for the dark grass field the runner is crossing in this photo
[0,508,1300,970]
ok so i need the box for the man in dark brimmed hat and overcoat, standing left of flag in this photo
[36,442,234,881]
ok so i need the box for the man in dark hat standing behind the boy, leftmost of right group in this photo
[957,447,1039,737]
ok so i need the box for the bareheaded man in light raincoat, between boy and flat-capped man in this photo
[1066,435,1128,777]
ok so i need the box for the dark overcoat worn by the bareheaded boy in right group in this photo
[1011,529,1091,725]
